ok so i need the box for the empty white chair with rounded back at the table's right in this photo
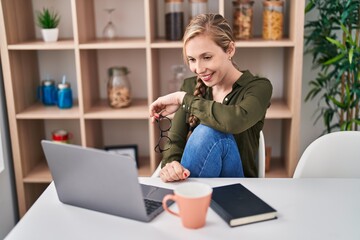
[293,131,360,178]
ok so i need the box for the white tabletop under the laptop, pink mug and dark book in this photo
[6,178,360,240]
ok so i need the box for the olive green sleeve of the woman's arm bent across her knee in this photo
[181,78,272,134]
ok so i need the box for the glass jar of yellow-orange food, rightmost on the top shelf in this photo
[262,0,284,40]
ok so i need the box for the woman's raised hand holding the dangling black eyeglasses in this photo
[149,91,186,122]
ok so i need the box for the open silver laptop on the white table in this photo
[41,140,173,222]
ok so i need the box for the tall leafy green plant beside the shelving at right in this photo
[305,0,360,132]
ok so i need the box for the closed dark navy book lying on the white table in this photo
[210,183,277,227]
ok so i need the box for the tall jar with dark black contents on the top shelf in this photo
[165,0,184,41]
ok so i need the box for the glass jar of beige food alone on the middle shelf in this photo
[107,67,131,108]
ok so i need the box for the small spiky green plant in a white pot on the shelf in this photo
[36,7,60,42]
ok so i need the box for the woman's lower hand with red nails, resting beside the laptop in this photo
[160,161,190,182]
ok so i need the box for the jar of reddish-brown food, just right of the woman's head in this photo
[233,0,254,39]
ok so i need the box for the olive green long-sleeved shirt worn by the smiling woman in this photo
[162,71,272,177]
